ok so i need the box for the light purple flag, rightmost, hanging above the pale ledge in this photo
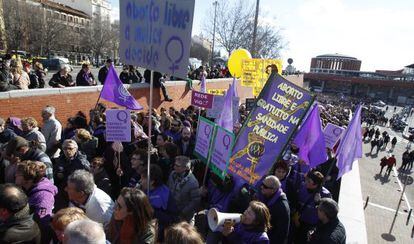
[336,105,362,179]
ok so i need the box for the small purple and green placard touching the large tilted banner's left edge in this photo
[210,126,234,180]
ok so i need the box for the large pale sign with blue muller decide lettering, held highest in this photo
[119,0,195,78]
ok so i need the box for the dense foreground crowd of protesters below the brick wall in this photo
[0,98,345,244]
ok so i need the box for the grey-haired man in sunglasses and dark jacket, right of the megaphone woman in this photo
[258,175,290,244]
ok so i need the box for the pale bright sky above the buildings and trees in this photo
[110,0,414,71]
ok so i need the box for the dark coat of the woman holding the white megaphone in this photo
[225,223,270,244]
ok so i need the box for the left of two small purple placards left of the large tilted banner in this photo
[194,117,215,163]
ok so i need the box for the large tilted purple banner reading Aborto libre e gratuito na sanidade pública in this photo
[229,74,313,185]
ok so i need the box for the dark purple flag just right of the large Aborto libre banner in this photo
[293,104,328,168]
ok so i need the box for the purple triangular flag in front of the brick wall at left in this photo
[101,65,142,110]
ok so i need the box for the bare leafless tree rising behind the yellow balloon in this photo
[203,0,284,58]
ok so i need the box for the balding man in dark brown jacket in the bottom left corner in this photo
[0,184,41,244]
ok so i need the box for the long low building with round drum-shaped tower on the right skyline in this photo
[304,54,414,104]
